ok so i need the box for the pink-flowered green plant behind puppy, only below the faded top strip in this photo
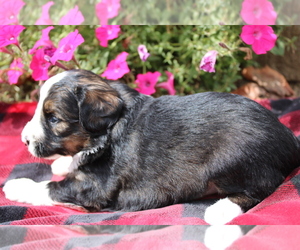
[0,25,292,101]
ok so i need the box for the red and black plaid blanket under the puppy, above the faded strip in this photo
[0,99,300,227]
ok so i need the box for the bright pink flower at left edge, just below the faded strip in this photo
[0,25,25,47]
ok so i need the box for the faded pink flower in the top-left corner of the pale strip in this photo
[0,0,25,25]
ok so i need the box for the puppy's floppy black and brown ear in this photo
[75,82,123,134]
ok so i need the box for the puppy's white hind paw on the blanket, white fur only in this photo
[204,198,243,225]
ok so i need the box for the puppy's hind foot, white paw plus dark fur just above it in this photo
[204,193,258,225]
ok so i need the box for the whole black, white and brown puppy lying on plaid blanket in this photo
[4,70,300,224]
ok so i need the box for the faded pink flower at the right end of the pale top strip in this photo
[241,0,277,25]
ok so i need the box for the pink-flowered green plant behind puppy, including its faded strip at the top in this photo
[0,0,298,102]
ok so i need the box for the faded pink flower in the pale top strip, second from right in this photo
[96,0,121,25]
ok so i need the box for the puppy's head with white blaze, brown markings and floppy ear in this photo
[22,70,123,159]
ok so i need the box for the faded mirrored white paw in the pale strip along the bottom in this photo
[204,225,243,250]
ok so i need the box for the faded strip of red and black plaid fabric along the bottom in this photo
[0,225,300,250]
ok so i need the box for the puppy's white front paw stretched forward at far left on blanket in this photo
[3,178,54,206]
